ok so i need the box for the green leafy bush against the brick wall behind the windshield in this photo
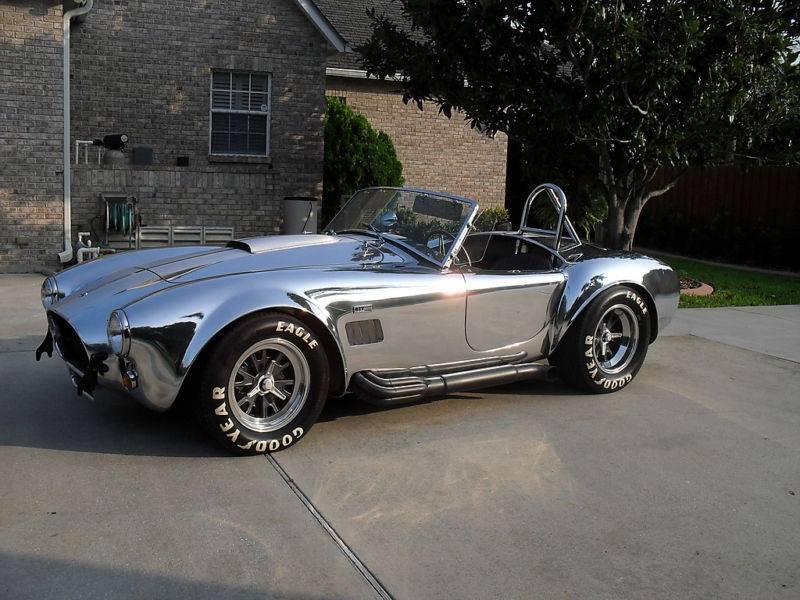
[322,98,403,224]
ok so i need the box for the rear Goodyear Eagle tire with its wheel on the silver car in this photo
[551,287,650,394]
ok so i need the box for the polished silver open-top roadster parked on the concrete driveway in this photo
[36,184,679,454]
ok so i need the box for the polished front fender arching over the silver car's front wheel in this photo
[125,272,346,410]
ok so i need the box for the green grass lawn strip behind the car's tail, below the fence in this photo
[658,256,800,308]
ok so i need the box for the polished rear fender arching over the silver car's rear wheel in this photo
[547,253,680,354]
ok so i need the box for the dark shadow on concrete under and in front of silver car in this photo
[0,339,575,458]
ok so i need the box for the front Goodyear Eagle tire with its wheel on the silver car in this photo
[195,314,329,454]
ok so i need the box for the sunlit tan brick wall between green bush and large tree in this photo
[326,77,508,208]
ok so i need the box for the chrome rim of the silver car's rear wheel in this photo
[594,304,639,375]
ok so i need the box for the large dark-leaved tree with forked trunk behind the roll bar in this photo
[357,0,800,248]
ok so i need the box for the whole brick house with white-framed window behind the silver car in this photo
[0,0,507,271]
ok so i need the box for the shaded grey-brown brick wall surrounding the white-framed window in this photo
[72,0,327,244]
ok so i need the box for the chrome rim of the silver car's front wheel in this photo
[228,338,311,432]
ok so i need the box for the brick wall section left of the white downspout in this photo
[0,0,64,271]
